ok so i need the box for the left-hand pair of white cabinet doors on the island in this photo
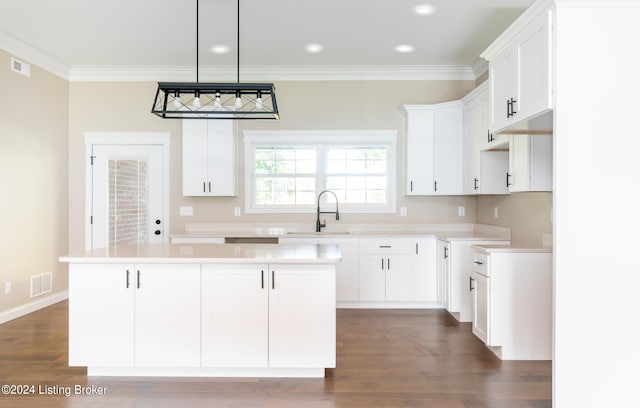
[69,264,200,367]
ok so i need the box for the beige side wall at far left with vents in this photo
[0,50,69,312]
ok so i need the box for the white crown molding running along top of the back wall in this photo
[69,66,476,82]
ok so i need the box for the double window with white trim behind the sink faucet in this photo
[245,131,396,213]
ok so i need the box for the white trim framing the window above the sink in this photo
[243,130,398,214]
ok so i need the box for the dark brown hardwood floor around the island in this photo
[0,302,551,408]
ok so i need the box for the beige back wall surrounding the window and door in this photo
[69,81,475,248]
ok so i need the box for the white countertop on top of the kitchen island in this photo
[59,244,341,264]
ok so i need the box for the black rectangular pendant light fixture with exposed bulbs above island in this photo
[151,0,280,119]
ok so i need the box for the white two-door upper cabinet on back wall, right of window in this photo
[402,101,464,195]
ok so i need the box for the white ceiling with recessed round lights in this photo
[0,0,533,80]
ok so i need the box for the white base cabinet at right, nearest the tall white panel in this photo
[471,249,552,360]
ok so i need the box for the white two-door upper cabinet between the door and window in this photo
[182,119,237,196]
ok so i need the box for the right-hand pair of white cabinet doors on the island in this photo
[202,264,336,368]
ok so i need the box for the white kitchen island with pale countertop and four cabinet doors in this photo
[60,244,340,377]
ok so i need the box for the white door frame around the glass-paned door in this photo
[84,132,171,250]
